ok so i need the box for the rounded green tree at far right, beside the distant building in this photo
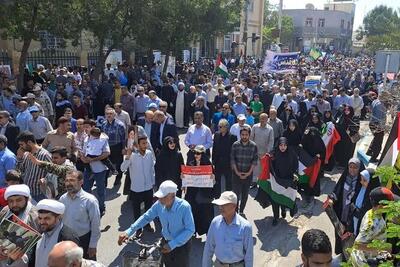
[356,5,400,51]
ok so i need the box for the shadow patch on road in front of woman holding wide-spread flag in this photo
[254,217,300,257]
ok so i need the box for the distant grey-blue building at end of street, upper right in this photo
[283,3,355,52]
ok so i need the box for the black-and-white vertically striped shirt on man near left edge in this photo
[17,148,51,196]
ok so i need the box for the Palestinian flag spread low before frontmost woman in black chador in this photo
[257,155,297,209]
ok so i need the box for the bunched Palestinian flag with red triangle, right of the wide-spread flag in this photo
[299,148,321,188]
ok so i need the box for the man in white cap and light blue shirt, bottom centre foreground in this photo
[202,191,253,267]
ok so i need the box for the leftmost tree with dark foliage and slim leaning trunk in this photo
[0,0,76,88]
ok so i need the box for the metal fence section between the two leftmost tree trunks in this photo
[26,50,80,67]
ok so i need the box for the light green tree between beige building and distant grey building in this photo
[262,1,294,46]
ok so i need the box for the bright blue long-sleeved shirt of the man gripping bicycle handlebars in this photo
[125,197,194,250]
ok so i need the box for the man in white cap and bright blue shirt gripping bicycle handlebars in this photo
[118,180,194,267]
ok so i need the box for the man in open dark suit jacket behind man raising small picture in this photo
[150,110,179,155]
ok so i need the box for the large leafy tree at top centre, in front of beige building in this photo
[137,0,243,72]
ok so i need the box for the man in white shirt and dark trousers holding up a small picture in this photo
[121,136,155,237]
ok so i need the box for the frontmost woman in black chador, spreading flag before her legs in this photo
[270,137,299,226]
